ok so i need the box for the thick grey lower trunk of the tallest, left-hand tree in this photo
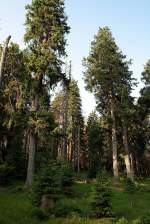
[25,133,37,189]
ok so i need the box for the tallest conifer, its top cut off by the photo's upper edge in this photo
[24,0,69,187]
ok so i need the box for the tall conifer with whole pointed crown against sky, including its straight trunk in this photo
[84,27,134,182]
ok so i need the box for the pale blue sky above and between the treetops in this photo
[0,0,150,115]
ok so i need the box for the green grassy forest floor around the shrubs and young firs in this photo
[0,179,150,224]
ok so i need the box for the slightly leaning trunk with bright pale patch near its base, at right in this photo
[123,121,134,180]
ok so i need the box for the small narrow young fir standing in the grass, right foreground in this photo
[92,171,113,218]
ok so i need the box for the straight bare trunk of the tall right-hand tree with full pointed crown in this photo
[110,96,119,183]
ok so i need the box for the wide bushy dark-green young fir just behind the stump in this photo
[33,160,74,206]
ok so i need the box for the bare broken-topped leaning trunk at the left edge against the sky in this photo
[0,36,11,87]
